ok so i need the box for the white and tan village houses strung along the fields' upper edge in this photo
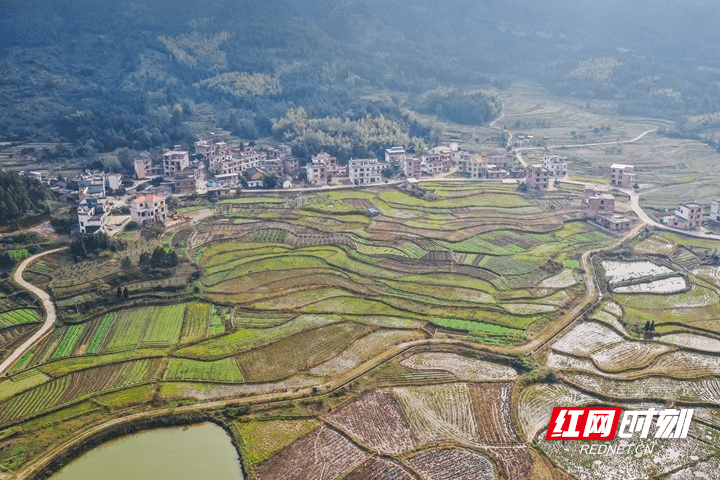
[28,129,720,238]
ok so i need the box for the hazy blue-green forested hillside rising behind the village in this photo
[0,0,720,154]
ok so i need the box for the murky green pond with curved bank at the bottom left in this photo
[50,423,243,480]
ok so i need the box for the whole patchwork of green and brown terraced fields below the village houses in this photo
[0,184,720,479]
